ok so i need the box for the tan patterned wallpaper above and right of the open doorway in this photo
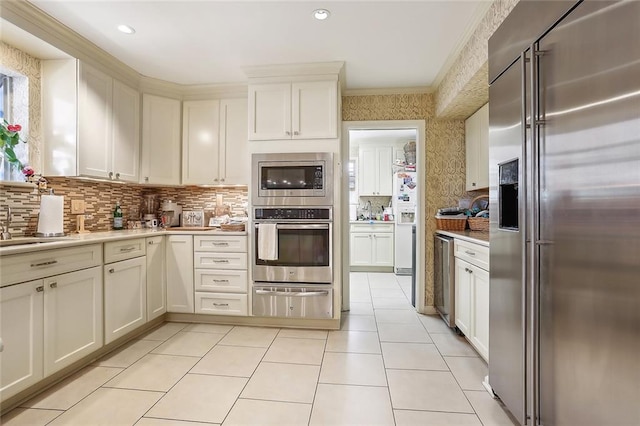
[342,94,488,306]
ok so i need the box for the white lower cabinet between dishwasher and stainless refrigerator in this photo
[454,239,489,361]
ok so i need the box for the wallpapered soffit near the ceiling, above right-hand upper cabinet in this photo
[436,0,519,119]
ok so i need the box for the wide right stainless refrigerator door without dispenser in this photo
[536,1,640,425]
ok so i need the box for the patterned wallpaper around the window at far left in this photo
[0,41,42,170]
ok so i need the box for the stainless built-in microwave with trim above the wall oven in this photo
[251,152,333,206]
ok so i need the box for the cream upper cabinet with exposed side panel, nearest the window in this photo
[42,60,140,182]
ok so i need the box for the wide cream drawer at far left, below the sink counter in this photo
[0,244,102,286]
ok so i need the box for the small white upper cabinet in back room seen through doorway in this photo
[358,146,393,196]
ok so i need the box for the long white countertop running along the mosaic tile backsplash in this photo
[0,228,247,256]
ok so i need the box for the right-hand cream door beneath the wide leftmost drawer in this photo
[44,266,103,376]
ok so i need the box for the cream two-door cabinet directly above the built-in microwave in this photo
[249,79,338,140]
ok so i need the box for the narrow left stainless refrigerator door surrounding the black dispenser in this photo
[489,58,527,423]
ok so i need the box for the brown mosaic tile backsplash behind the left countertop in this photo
[0,177,248,236]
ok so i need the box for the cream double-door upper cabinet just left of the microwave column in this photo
[182,99,251,185]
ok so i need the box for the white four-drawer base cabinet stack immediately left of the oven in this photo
[194,235,249,316]
